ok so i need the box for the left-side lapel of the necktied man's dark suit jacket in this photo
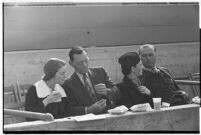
[71,73,90,105]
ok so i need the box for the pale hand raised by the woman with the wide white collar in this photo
[43,91,61,106]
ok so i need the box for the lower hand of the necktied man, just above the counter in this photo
[87,99,106,114]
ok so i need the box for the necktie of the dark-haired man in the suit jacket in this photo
[83,74,97,103]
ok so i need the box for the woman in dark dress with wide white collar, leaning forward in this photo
[25,58,69,120]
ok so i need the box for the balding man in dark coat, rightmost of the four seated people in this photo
[139,44,189,106]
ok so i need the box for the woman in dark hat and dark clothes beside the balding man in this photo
[117,52,152,108]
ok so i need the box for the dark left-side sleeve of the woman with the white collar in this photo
[25,86,45,113]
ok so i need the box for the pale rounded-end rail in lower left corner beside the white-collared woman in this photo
[4,109,54,121]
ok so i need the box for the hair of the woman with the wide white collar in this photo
[43,58,66,81]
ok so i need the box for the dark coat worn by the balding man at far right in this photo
[143,67,189,106]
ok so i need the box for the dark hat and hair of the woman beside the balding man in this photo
[118,52,140,75]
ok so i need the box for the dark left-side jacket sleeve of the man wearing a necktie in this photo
[62,84,86,116]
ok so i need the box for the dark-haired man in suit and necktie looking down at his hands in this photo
[63,46,120,115]
